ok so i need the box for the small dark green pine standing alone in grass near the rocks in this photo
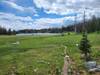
[79,32,91,61]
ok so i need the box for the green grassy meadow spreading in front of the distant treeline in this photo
[0,33,100,75]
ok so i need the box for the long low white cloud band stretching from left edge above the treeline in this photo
[0,12,74,30]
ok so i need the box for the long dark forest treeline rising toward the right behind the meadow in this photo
[17,16,100,33]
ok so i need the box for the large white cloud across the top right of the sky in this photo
[33,0,100,15]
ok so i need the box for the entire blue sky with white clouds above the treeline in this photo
[0,0,100,30]
